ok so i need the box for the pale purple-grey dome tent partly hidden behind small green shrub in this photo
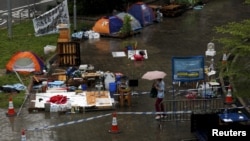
[116,12,142,31]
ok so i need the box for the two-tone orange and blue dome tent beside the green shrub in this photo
[92,16,123,34]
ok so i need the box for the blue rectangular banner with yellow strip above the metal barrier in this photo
[172,56,205,82]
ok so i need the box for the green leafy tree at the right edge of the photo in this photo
[215,4,250,97]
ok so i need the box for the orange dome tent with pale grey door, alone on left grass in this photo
[6,51,45,73]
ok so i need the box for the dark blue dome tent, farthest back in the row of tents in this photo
[128,2,155,26]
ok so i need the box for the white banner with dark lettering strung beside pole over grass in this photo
[33,0,70,36]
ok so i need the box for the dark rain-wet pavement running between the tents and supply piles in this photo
[0,0,250,141]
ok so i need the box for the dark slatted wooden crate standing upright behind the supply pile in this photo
[57,42,81,66]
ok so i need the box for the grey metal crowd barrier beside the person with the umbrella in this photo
[162,98,224,121]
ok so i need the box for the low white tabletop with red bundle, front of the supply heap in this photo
[29,90,113,112]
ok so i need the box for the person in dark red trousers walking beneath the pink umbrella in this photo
[154,79,166,119]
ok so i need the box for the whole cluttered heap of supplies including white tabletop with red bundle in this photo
[29,64,138,112]
